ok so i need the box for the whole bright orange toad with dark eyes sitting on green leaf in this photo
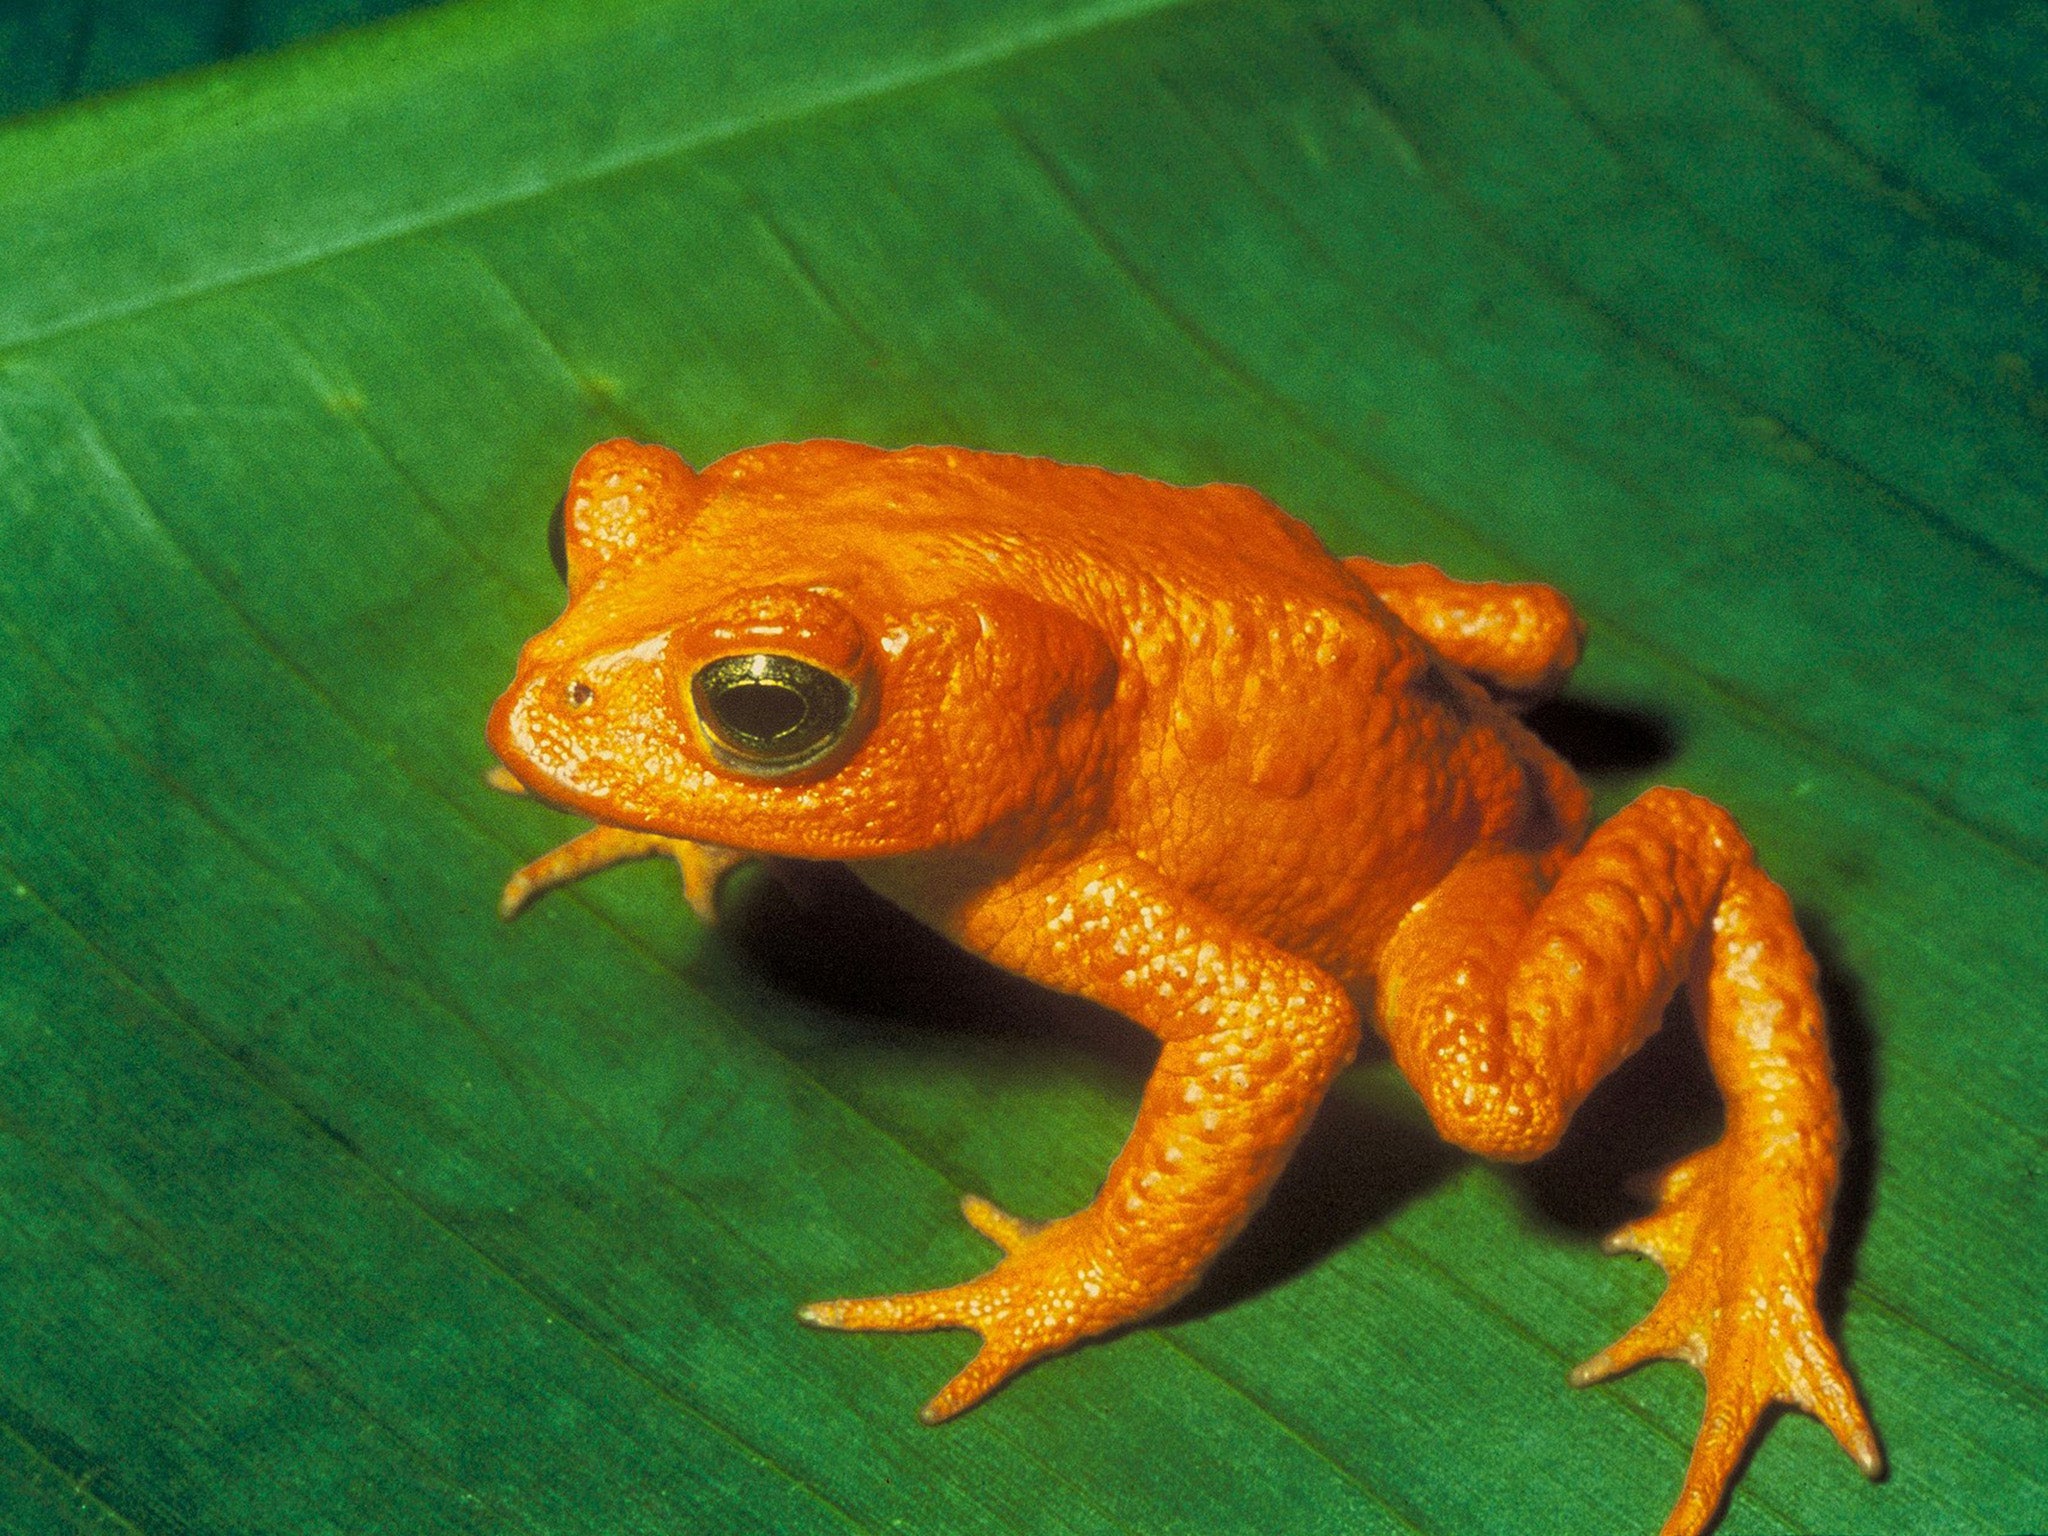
[489,440,1880,1532]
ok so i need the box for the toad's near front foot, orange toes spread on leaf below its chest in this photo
[797,1194,1180,1423]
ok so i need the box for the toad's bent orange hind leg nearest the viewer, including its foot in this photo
[1378,788,1882,1536]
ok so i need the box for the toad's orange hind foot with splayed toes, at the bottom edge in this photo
[1571,1141,1884,1536]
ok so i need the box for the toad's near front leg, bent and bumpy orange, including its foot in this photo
[803,852,1358,1423]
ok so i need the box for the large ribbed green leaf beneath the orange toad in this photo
[0,0,2048,1534]
